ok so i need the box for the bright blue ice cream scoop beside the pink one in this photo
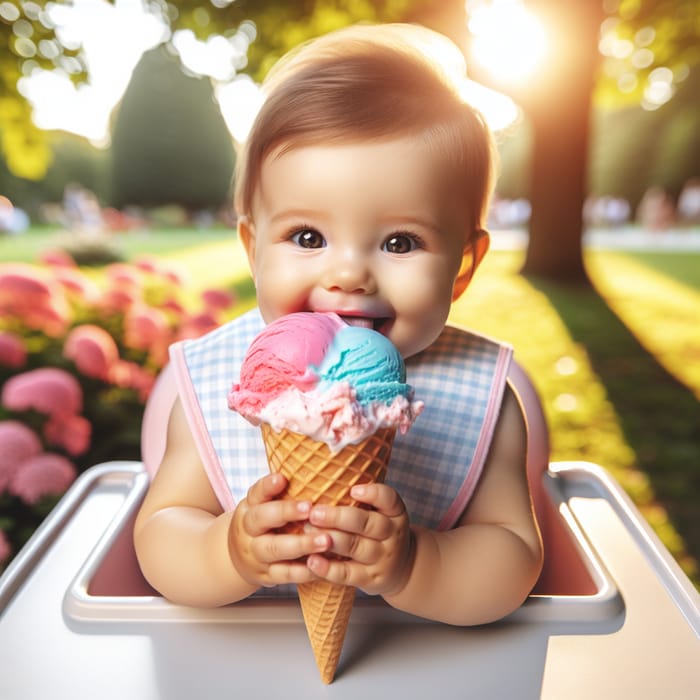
[317,326,413,406]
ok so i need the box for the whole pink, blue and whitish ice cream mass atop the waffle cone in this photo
[228,312,423,452]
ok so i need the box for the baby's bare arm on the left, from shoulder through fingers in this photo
[134,400,329,607]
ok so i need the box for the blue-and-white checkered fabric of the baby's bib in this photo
[172,309,511,528]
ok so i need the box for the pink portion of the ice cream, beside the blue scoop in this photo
[231,312,345,415]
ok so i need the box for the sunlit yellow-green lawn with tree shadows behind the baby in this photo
[0,230,700,585]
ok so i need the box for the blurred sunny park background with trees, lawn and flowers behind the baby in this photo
[0,0,700,585]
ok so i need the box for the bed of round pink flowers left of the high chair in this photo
[0,253,235,567]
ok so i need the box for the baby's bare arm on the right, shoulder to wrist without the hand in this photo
[386,389,542,625]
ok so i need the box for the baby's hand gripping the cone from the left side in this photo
[229,474,332,587]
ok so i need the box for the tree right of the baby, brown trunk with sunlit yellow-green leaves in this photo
[460,0,700,283]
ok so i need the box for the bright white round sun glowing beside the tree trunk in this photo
[466,0,548,83]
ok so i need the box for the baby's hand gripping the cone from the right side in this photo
[307,484,413,595]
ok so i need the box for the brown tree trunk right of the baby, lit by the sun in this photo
[521,0,602,283]
